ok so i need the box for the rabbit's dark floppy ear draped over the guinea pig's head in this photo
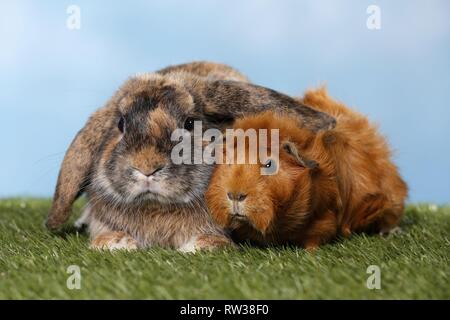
[192,80,336,132]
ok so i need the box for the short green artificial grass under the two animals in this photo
[0,199,450,299]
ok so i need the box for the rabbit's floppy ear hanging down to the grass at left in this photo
[45,105,116,230]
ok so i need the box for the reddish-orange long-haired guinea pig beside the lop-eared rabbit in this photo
[205,88,407,250]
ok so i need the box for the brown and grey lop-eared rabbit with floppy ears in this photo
[46,62,335,252]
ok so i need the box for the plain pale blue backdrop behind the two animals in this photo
[0,0,450,203]
